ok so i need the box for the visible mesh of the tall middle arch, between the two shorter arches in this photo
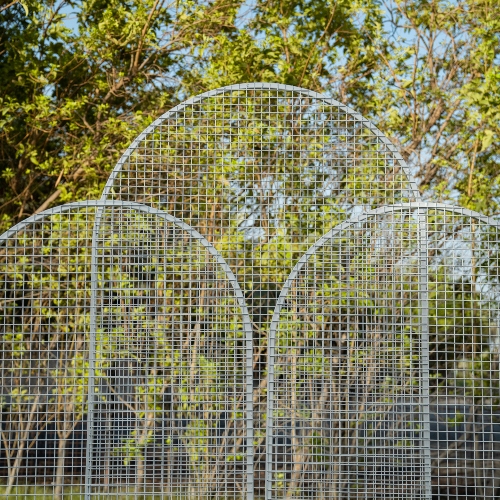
[103,83,419,493]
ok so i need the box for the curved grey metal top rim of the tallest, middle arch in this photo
[101,82,421,200]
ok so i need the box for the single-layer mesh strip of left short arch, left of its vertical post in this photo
[0,201,94,500]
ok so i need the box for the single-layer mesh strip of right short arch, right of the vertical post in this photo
[427,207,500,500]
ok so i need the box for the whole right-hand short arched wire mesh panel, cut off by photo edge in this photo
[266,204,500,500]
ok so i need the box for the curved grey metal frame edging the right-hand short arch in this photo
[265,202,500,500]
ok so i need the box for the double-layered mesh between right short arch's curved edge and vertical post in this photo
[267,205,428,499]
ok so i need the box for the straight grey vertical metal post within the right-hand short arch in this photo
[417,209,432,500]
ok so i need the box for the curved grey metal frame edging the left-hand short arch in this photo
[0,200,254,500]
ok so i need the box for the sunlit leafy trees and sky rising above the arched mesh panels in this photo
[0,0,500,234]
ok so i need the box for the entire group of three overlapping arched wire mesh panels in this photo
[0,84,500,500]
